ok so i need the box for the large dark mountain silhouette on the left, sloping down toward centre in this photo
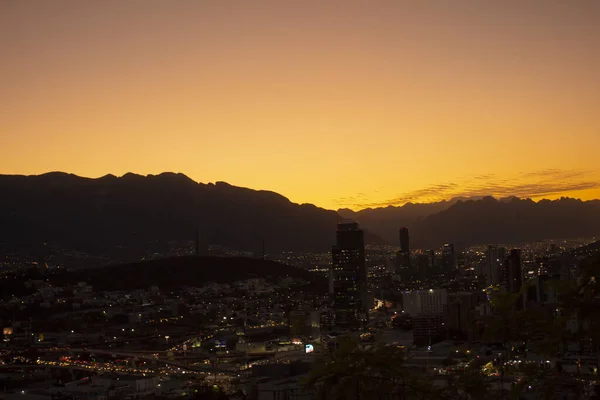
[0,172,381,253]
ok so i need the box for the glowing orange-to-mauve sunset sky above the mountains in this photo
[0,0,600,209]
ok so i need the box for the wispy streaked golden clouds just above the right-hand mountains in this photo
[337,169,600,208]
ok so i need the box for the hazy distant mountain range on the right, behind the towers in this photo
[338,196,600,247]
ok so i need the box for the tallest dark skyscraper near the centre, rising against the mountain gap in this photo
[331,222,369,326]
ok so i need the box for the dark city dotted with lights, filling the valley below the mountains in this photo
[0,221,600,399]
